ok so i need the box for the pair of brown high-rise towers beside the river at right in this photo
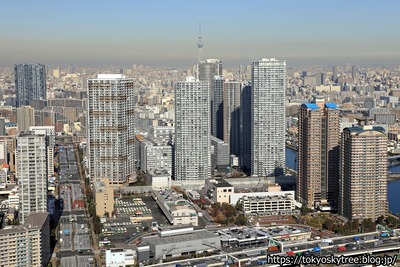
[296,97,388,219]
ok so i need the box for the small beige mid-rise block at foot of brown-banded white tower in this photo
[94,178,114,217]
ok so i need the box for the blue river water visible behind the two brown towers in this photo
[286,147,400,214]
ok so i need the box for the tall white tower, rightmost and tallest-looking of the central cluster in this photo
[251,58,286,176]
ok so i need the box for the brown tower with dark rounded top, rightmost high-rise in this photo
[339,125,388,220]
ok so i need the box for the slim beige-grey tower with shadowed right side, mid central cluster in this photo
[223,81,242,156]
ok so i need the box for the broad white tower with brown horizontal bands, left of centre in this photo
[88,74,136,185]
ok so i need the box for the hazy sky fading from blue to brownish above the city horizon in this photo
[0,0,400,67]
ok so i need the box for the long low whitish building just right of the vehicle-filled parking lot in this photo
[152,189,198,226]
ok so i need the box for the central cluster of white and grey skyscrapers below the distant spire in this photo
[171,59,286,180]
